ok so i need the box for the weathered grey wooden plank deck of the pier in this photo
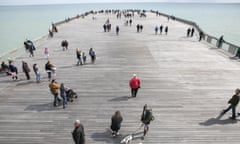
[0,13,240,144]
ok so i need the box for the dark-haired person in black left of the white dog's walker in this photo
[111,111,123,137]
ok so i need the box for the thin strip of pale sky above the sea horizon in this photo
[0,0,240,5]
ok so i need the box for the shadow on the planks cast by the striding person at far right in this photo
[199,114,238,126]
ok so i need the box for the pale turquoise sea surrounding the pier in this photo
[0,3,240,56]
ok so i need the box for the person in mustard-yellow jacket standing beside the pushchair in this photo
[49,80,61,107]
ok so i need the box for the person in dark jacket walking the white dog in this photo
[141,104,154,139]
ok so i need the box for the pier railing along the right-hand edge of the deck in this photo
[151,11,240,56]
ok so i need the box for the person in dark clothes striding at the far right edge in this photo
[221,89,240,120]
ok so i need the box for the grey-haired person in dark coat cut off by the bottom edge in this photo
[72,120,85,144]
